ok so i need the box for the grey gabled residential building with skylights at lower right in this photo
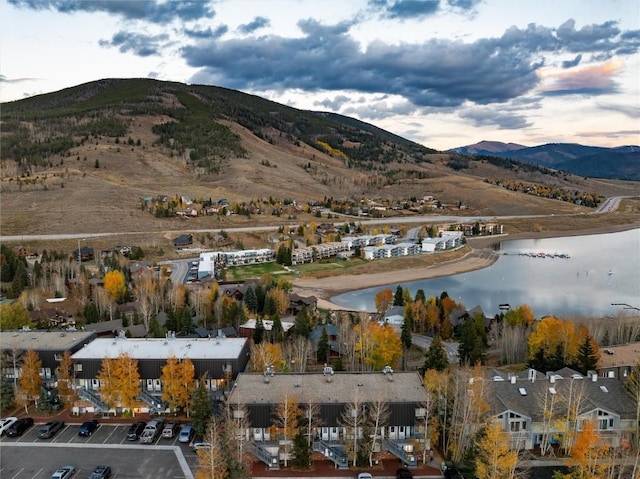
[485,368,637,454]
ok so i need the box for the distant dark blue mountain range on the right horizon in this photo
[448,141,640,181]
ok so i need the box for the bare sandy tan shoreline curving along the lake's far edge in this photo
[293,224,638,311]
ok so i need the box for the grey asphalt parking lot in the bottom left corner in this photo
[0,424,197,479]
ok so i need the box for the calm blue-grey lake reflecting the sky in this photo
[331,229,640,317]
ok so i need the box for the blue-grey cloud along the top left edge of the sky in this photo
[8,0,215,24]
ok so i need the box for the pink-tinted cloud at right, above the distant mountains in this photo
[540,61,622,96]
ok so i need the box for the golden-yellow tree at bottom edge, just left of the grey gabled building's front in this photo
[475,422,518,479]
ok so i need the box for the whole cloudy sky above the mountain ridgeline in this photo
[0,0,640,150]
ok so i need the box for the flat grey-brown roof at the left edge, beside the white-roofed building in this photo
[0,330,95,351]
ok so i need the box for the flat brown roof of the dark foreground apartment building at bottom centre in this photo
[229,372,427,404]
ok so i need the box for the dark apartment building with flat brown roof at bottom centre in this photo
[229,367,428,469]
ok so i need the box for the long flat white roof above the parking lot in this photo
[72,338,247,360]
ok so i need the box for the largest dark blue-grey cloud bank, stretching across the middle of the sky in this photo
[182,20,539,107]
